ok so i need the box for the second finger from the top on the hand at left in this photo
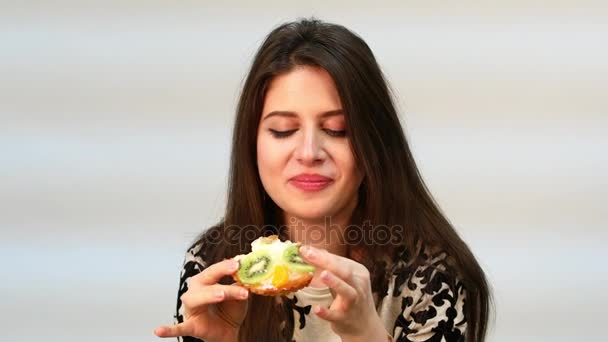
[181,284,249,308]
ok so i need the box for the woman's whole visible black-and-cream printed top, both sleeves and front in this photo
[174,240,467,342]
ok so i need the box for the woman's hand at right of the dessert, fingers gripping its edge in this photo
[300,246,388,342]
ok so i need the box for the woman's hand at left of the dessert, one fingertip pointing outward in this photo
[154,259,249,342]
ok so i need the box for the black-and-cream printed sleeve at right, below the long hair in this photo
[393,267,467,342]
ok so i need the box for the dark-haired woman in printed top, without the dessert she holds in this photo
[155,20,490,342]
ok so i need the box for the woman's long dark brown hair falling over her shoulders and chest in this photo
[197,19,490,342]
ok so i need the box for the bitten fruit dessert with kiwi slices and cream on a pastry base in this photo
[233,235,315,296]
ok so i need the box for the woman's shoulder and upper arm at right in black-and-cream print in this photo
[391,249,467,342]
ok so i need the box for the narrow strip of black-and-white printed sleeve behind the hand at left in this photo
[173,244,207,342]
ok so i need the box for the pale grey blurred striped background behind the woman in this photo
[0,0,608,342]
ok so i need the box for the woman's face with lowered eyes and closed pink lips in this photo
[257,66,363,221]
